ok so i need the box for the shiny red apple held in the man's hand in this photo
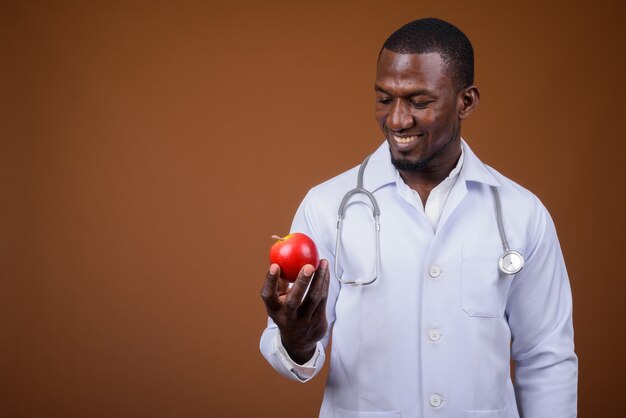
[270,232,320,282]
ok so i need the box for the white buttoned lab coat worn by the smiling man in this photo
[261,139,578,418]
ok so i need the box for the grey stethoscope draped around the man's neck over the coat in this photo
[334,155,524,286]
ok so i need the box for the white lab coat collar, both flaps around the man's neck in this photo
[363,138,500,193]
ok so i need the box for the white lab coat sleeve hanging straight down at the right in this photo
[506,203,578,418]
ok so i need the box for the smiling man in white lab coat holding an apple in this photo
[261,19,577,418]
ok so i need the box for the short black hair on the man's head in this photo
[381,17,474,90]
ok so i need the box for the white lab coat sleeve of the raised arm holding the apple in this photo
[260,192,337,383]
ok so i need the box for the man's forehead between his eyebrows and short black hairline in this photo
[376,49,452,92]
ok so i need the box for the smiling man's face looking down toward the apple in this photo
[375,49,463,172]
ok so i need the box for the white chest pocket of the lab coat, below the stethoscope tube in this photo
[461,242,514,318]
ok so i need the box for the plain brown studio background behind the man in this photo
[0,0,626,418]
